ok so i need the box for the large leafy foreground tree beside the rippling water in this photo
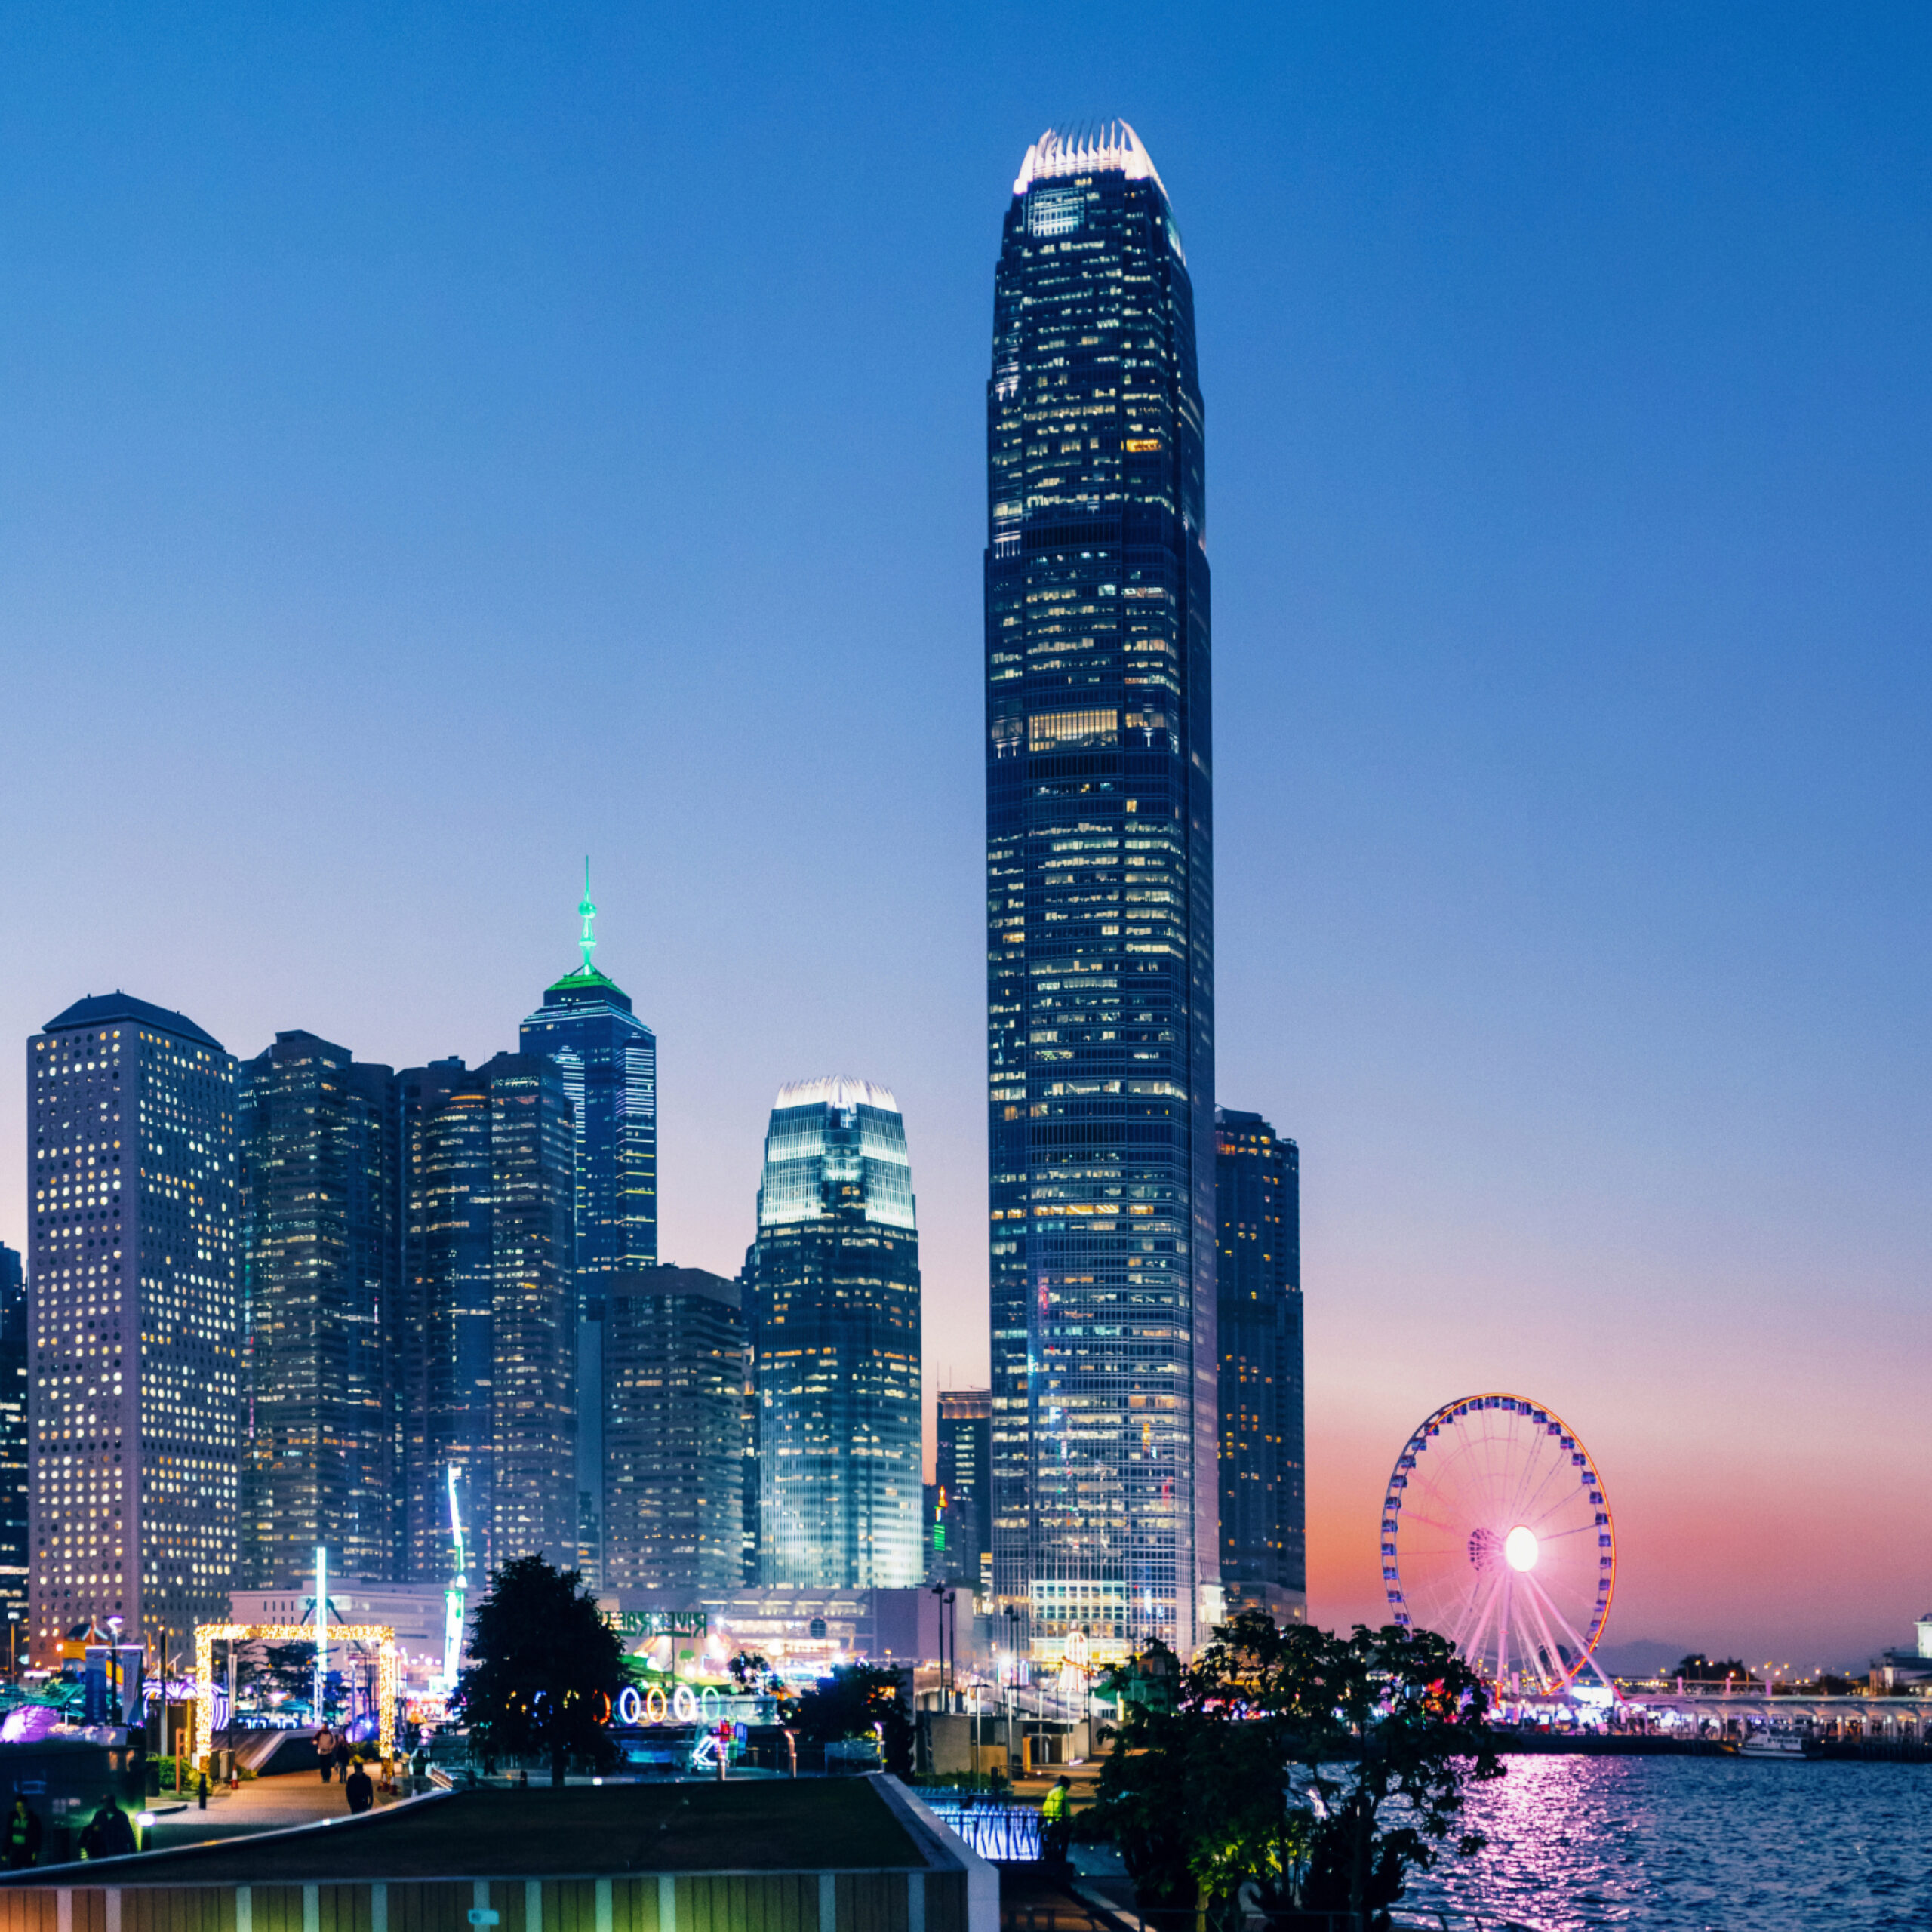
[1080,1611,1503,1932]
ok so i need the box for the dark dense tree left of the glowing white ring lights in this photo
[456,1557,624,1785]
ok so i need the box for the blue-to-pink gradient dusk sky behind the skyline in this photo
[0,0,1932,1663]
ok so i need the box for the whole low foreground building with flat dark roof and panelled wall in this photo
[0,1777,999,1932]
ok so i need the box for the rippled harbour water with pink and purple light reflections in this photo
[1403,1756,1932,1932]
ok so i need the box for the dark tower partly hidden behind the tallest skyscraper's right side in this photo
[1215,1107,1308,1623]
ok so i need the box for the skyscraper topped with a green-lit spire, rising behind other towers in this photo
[520,877,657,1586]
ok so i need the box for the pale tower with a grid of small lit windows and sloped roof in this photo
[27,993,242,1667]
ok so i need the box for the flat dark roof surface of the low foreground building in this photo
[0,1777,962,1890]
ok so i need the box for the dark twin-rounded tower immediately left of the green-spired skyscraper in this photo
[398,1053,576,1583]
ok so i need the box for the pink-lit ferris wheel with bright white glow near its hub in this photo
[1381,1395,1617,1693]
